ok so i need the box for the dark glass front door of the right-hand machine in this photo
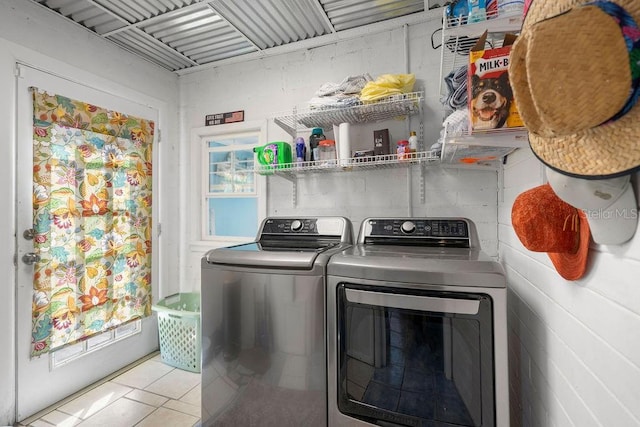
[337,284,495,427]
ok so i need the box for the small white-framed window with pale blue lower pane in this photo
[195,123,266,241]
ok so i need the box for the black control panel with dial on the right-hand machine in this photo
[358,218,477,248]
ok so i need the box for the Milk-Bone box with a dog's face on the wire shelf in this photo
[467,31,524,133]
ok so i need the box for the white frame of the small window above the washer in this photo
[188,120,267,245]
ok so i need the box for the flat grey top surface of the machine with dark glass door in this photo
[327,244,506,288]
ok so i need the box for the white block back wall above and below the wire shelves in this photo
[180,10,497,290]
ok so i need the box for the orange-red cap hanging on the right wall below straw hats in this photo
[511,184,590,280]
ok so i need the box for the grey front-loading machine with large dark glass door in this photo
[327,218,509,427]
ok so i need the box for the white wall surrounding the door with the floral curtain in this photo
[0,0,180,425]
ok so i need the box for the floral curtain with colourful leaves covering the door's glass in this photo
[31,88,154,356]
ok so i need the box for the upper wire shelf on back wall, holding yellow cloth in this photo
[274,91,424,137]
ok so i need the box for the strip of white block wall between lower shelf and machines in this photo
[269,167,497,249]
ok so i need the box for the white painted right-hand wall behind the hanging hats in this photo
[498,150,640,427]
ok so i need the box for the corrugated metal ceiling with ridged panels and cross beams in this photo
[31,0,425,71]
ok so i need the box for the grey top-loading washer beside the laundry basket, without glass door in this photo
[201,217,353,427]
